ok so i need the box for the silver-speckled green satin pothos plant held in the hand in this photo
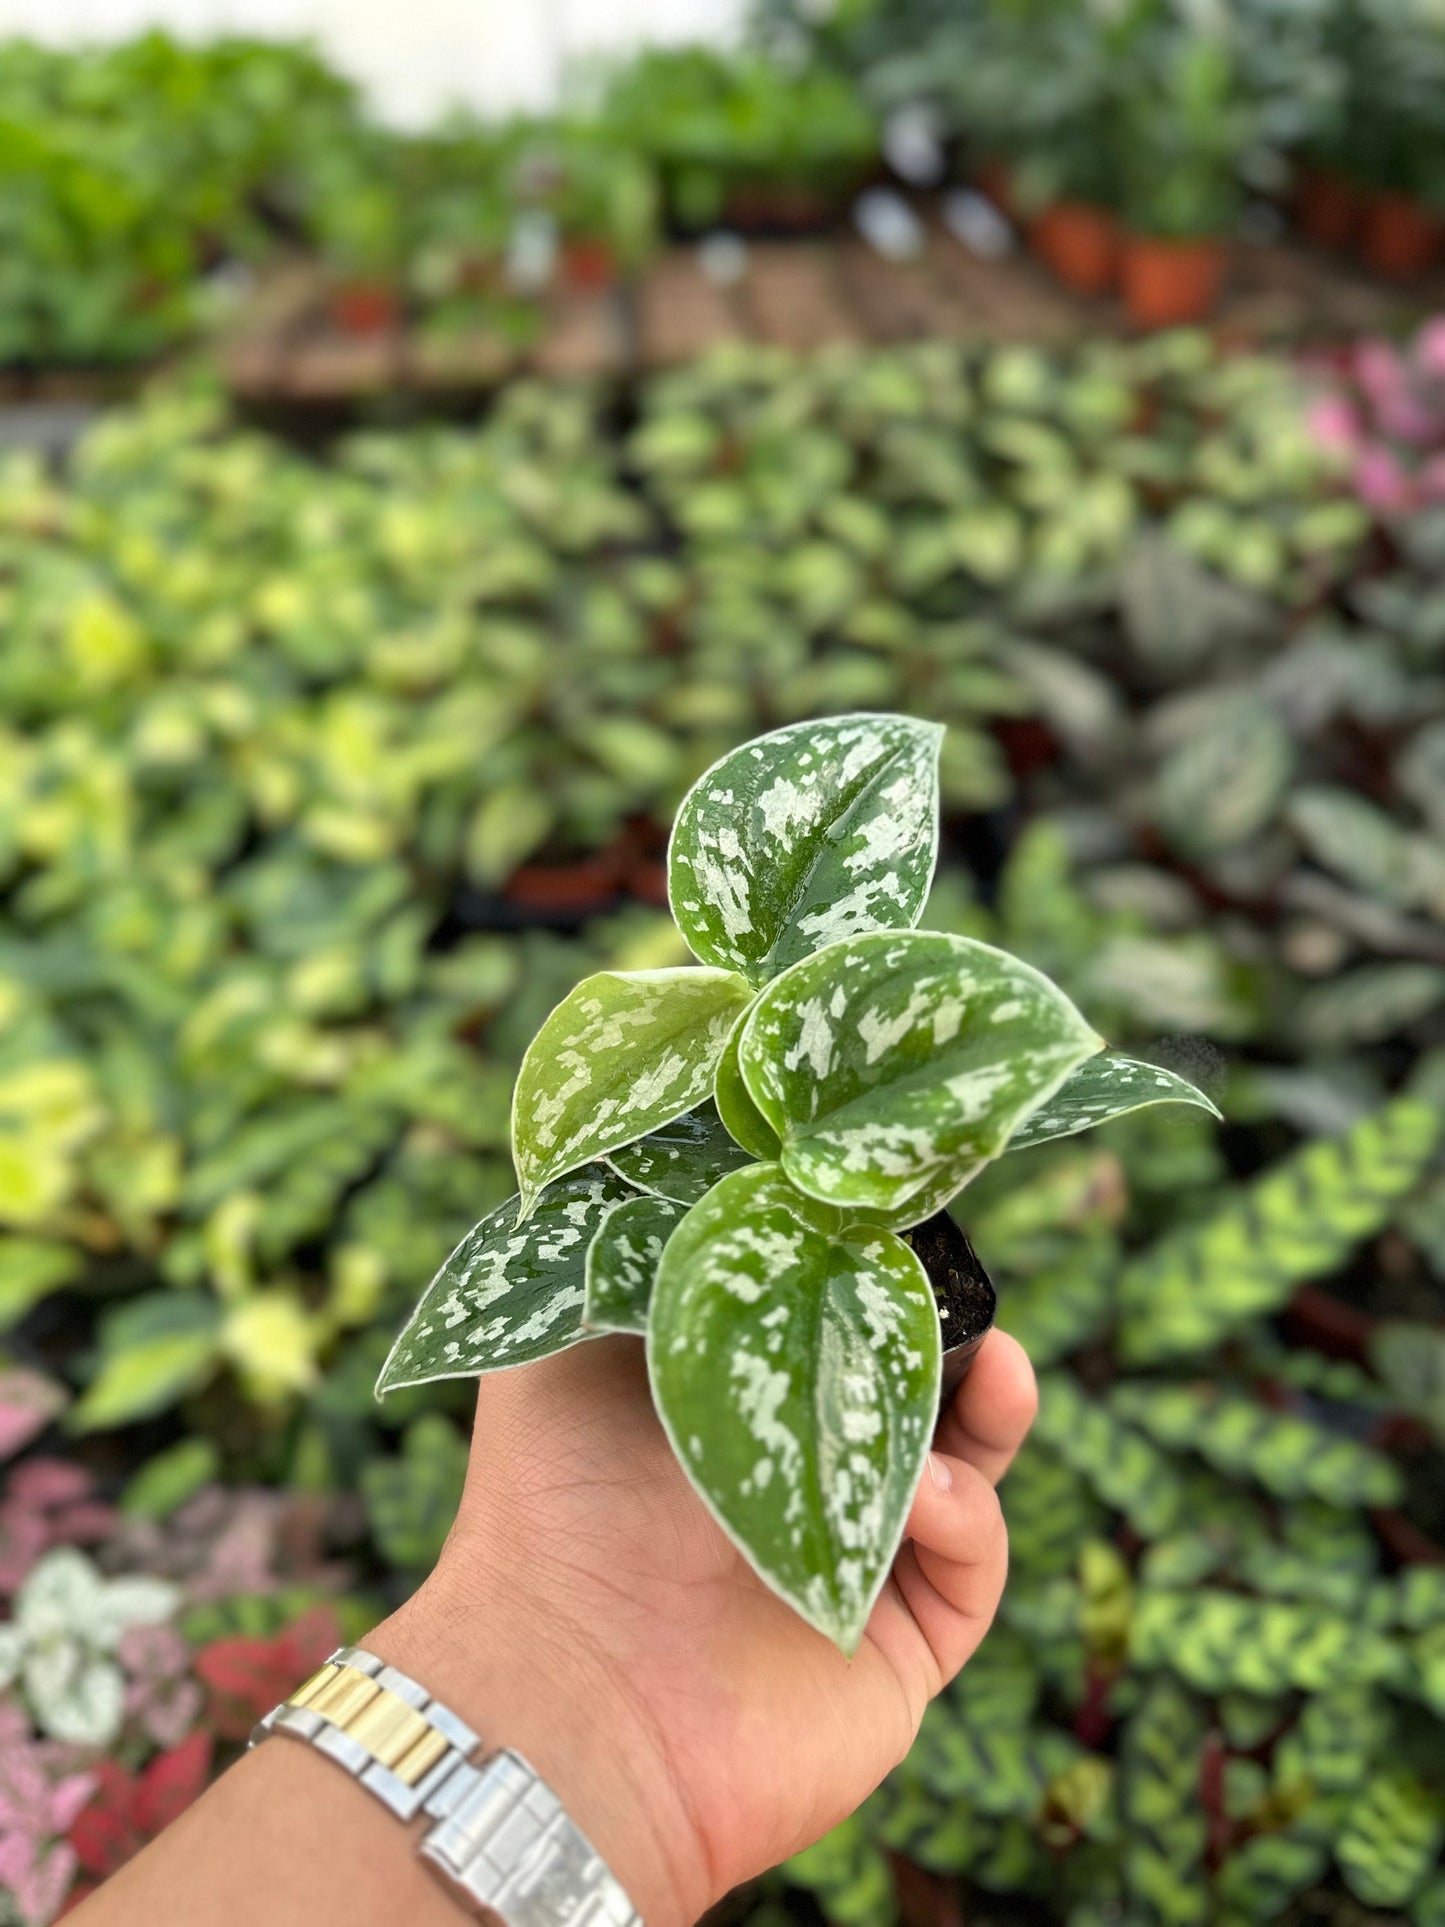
[378,715,1212,1653]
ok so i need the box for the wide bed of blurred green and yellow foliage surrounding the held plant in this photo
[0,335,1445,1927]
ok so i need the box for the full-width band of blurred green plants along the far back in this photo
[0,0,1445,368]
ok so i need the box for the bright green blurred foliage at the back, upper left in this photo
[0,31,877,368]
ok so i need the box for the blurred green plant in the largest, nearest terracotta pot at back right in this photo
[1119,25,1248,328]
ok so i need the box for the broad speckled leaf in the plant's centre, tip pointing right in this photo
[738,931,1100,1214]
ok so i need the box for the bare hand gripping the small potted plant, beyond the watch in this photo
[366,1332,1037,1927]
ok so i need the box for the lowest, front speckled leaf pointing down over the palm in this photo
[647,1164,940,1653]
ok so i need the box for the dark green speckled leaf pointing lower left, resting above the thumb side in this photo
[376,1166,638,1395]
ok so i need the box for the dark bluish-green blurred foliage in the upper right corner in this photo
[755,0,1445,237]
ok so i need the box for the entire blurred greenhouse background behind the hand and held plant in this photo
[0,0,1445,1927]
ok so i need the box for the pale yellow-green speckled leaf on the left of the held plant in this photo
[512,965,751,1216]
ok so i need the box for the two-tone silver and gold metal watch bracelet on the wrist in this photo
[250,1646,642,1927]
